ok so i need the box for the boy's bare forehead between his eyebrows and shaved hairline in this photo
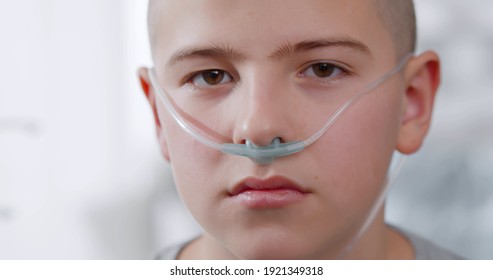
[150,0,391,63]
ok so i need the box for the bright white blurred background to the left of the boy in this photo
[0,0,173,258]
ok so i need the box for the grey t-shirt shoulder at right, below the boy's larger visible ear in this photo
[393,227,463,260]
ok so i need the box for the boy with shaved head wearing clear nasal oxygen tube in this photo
[139,0,453,259]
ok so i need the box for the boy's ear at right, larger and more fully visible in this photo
[397,51,440,154]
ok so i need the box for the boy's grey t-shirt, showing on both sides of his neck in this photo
[156,228,462,260]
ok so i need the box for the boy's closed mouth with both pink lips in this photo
[229,176,309,209]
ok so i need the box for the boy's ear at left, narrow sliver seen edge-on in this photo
[138,67,170,161]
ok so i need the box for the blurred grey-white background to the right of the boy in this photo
[387,0,493,259]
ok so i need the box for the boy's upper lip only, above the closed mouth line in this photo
[229,176,309,196]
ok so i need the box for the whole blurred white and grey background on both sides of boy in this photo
[0,0,493,259]
